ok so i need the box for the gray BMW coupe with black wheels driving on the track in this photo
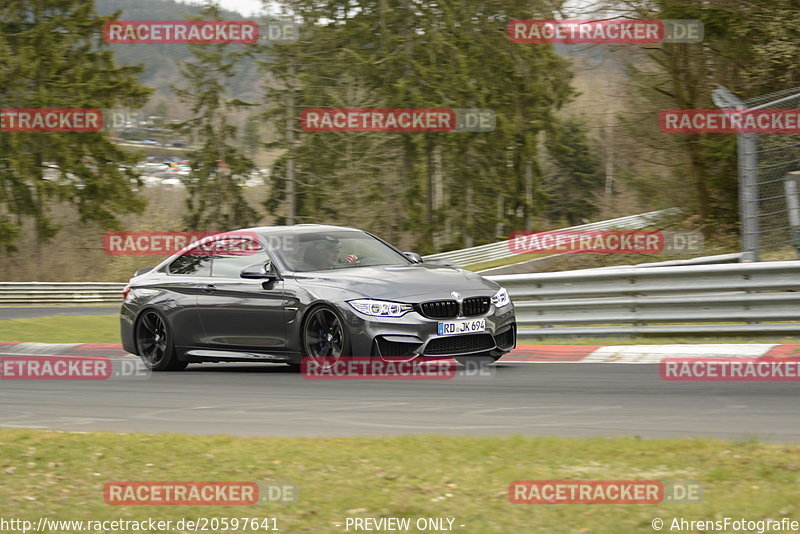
[120,224,516,371]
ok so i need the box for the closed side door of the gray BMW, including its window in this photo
[197,238,286,352]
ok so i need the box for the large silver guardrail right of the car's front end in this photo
[487,261,800,336]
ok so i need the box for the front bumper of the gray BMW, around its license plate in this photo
[340,303,517,359]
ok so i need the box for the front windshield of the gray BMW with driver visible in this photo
[276,231,412,272]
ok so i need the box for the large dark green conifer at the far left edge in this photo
[0,0,150,253]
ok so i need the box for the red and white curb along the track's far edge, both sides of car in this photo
[0,341,800,363]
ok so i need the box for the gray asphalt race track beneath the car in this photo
[0,356,800,442]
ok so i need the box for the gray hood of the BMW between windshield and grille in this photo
[288,264,500,303]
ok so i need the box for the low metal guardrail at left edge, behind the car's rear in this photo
[0,282,125,305]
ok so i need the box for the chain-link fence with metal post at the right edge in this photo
[714,87,800,261]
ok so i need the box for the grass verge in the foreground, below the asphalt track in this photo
[0,429,800,534]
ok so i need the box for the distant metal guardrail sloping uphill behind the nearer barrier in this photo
[422,208,683,267]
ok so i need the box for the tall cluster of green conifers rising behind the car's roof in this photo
[263,0,572,253]
